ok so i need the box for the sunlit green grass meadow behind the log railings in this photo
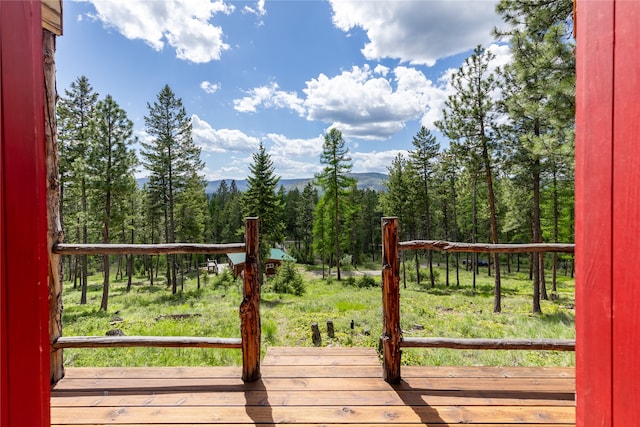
[63,264,575,366]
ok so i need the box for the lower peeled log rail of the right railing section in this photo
[400,337,576,351]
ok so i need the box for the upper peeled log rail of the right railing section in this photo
[398,240,575,254]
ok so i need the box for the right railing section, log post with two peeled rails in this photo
[380,218,575,384]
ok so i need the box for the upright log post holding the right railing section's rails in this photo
[381,218,402,384]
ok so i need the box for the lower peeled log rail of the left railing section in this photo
[51,336,242,350]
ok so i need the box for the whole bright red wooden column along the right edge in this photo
[576,0,640,427]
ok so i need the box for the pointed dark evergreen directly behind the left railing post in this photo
[243,143,285,280]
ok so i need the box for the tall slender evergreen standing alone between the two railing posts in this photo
[316,128,355,280]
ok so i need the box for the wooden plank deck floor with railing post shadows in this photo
[51,348,575,427]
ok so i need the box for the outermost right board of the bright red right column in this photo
[612,0,640,426]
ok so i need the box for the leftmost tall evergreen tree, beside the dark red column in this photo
[57,76,98,304]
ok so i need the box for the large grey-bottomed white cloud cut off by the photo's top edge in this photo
[330,0,501,66]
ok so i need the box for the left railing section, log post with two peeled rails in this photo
[51,218,260,382]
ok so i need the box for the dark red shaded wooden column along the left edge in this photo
[0,0,49,427]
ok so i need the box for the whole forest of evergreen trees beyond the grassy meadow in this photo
[58,0,575,312]
